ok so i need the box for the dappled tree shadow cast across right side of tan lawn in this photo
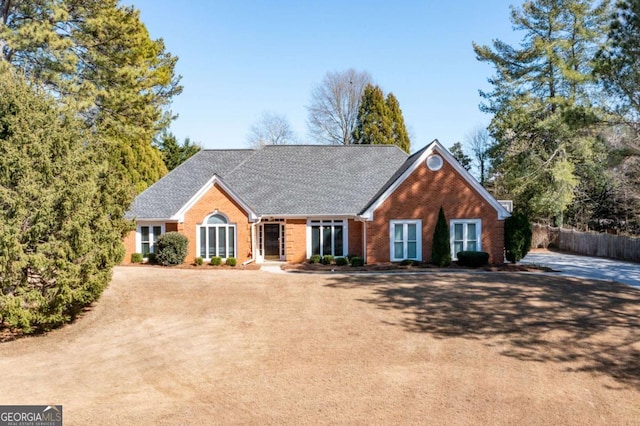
[328,273,640,389]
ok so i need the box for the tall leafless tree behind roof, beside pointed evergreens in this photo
[307,68,372,145]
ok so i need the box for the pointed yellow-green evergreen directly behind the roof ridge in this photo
[353,85,410,152]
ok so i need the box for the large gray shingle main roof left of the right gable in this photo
[128,145,407,219]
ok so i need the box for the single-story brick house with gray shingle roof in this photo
[124,140,509,263]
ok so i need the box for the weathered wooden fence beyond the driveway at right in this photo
[531,224,640,262]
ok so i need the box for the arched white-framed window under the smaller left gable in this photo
[198,213,236,259]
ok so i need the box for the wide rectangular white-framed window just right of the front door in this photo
[307,220,347,257]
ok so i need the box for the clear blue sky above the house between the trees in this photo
[123,0,519,151]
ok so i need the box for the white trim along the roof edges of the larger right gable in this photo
[361,139,511,220]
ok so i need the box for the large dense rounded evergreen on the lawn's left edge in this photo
[0,71,131,333]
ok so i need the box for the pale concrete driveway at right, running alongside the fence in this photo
[521,251,640,288]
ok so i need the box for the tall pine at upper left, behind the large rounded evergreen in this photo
[0,0,181,191]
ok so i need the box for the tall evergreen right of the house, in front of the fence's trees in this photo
[474,0,608,225]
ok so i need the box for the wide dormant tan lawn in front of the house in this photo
[0,267,640,425]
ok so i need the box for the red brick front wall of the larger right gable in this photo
[367,150,504,263]
